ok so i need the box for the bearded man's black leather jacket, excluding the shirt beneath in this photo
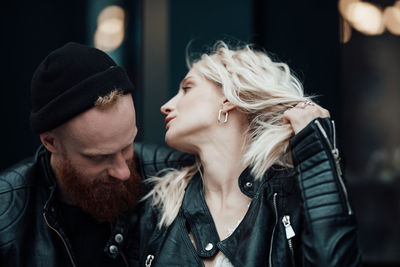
[0,144,187,267]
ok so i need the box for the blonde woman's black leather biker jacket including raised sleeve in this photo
[136,119,361,267]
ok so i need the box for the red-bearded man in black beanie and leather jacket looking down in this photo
[0,43,190,267]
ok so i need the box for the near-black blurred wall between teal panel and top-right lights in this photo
[253,0,340,120]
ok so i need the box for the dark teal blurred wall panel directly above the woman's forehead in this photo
[169,0,253,97]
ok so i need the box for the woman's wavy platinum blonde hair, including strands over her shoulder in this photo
[144,41,308,227]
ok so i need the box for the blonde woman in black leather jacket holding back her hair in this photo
[136,42,360,267]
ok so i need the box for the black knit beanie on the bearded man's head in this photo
[30,43,134,133]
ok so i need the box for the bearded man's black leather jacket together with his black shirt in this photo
[0,144,191,267]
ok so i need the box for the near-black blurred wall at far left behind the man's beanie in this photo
[0,0,86,170]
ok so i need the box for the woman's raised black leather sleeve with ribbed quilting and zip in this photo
[291,118,361,266]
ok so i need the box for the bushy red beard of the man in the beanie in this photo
[56,158,142,222]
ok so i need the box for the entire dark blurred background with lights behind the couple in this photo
[0,0,400,266]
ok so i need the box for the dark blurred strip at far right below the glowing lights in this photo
[340,30,400,266]
